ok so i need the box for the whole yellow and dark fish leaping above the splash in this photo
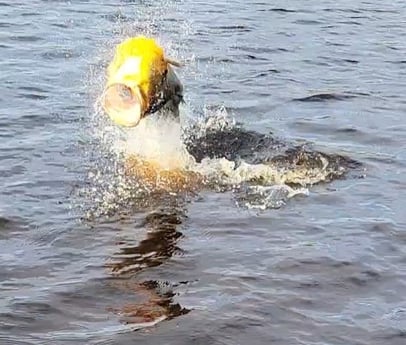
[101,35,183,128]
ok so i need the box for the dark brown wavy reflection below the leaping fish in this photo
[106,200,190,326]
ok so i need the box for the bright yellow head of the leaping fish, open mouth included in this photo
[101,36,175,127]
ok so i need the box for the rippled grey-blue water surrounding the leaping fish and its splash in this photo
[0,0,406,345]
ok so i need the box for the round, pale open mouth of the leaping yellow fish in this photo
[101,83,145,127]
